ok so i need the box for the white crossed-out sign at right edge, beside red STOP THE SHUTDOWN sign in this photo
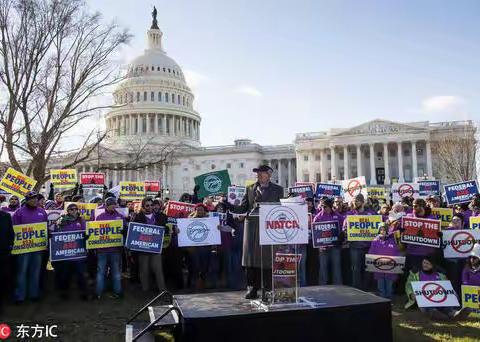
[442,229,480,258]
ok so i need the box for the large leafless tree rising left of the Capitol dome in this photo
[0,0,130,188]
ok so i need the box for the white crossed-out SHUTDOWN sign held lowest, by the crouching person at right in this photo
[412,280,460,308]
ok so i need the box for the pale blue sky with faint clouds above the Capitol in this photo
[84,0,480,146]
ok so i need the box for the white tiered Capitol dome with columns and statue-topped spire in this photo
[105,11,201,148]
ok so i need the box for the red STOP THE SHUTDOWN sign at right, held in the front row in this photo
[400,217,442,248]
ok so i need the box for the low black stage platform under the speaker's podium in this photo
[149,286,392,342]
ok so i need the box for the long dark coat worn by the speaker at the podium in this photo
[235,182,283,268]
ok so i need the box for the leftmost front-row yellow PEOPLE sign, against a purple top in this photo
[12,222,48,254]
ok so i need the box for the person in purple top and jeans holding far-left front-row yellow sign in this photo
[12,191,48,303]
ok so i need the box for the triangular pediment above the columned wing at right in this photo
[332,119,426,136]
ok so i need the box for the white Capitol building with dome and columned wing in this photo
[69,14,473,199]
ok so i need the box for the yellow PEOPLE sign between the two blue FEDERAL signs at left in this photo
[87,220,123,249]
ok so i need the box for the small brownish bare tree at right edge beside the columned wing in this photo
[432,126,479,182]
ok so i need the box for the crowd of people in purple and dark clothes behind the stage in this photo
[0,168,480,319]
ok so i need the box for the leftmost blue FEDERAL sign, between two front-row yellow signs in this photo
[50,230,87,261]
